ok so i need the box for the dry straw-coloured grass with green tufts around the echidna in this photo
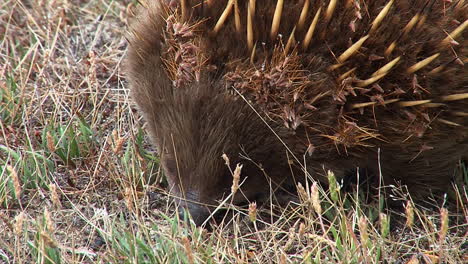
[0,0,468,263]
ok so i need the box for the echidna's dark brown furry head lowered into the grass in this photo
[152,84,289,225]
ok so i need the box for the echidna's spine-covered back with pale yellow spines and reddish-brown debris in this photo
[155,0,468,152]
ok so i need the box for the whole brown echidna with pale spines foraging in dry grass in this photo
[127,0,468,224]
